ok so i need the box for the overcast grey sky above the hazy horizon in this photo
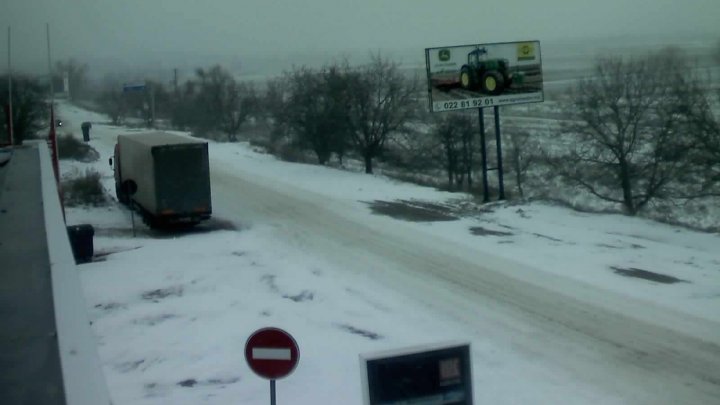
[0,0,720,75]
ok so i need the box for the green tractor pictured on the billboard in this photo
[460,48,522,96]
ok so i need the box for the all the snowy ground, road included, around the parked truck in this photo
[56,100,720,405]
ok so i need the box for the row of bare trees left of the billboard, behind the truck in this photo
[92,56,421,173]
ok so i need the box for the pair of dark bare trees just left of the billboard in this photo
[267,56,418,173]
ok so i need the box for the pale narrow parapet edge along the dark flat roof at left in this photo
[38,143,112,405]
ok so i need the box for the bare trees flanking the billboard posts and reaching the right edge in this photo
[390,47,720,215]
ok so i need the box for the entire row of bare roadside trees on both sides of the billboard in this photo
[87,45,720,215]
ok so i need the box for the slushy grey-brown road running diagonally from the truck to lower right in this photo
[211,165,720,404]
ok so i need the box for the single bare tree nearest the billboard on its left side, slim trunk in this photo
[348,55,418,173]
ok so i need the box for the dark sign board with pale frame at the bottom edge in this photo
[360,343,473,405]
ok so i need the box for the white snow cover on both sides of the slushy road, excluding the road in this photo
[59,104,720,405]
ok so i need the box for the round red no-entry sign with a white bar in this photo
[245,328,300,380]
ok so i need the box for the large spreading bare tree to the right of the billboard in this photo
[551,50,704,215]
